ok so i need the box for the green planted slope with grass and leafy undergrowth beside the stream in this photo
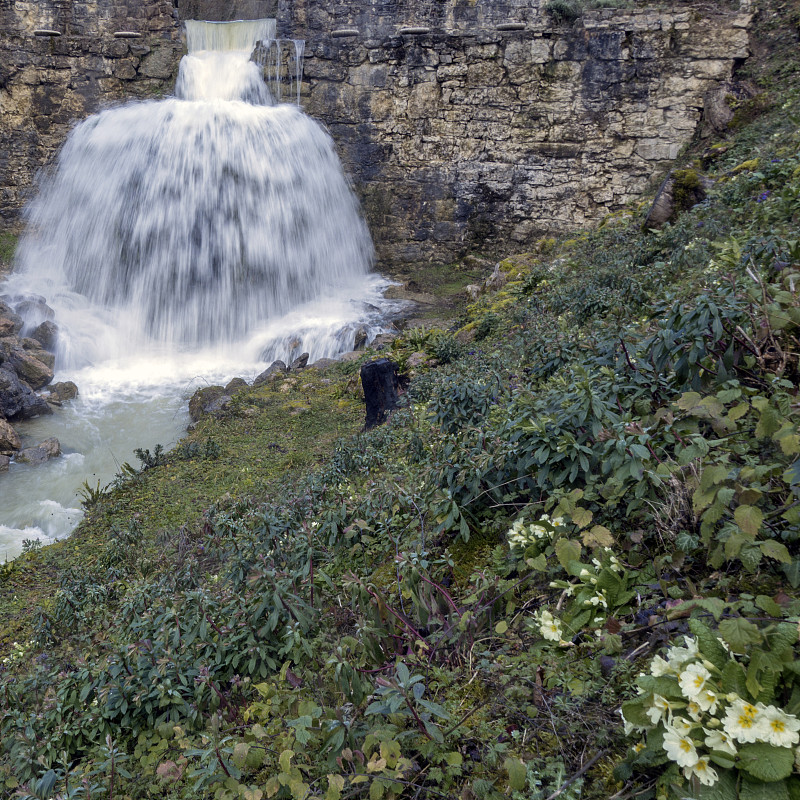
[0,3,800,800]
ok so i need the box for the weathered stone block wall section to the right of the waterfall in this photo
[278,0,750,264]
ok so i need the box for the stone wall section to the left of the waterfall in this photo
[0,0,182,227]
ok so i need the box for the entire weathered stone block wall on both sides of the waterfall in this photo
[0,0,750,266]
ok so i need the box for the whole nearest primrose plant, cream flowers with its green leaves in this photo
[621,619,800,800]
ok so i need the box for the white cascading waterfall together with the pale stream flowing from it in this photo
[0,20,396,558]
